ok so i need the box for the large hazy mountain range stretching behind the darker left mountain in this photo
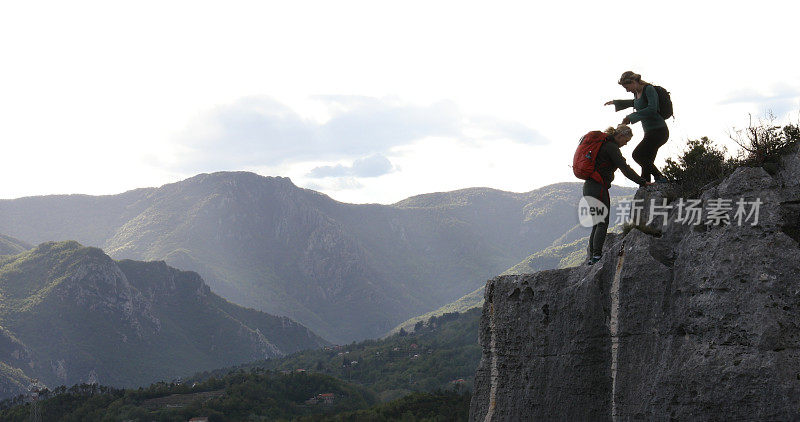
[0,172,632,343]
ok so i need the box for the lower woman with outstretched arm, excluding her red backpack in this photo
[583,125,649,265]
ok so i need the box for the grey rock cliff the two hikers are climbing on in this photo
[470,148,800,421]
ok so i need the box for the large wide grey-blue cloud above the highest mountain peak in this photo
[171,96,546,173]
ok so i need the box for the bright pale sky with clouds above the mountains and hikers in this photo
[0,0,800,203]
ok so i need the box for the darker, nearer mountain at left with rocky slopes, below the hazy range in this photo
[0,241,327,396]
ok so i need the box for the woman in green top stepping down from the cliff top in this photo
[605,70,669,182]
